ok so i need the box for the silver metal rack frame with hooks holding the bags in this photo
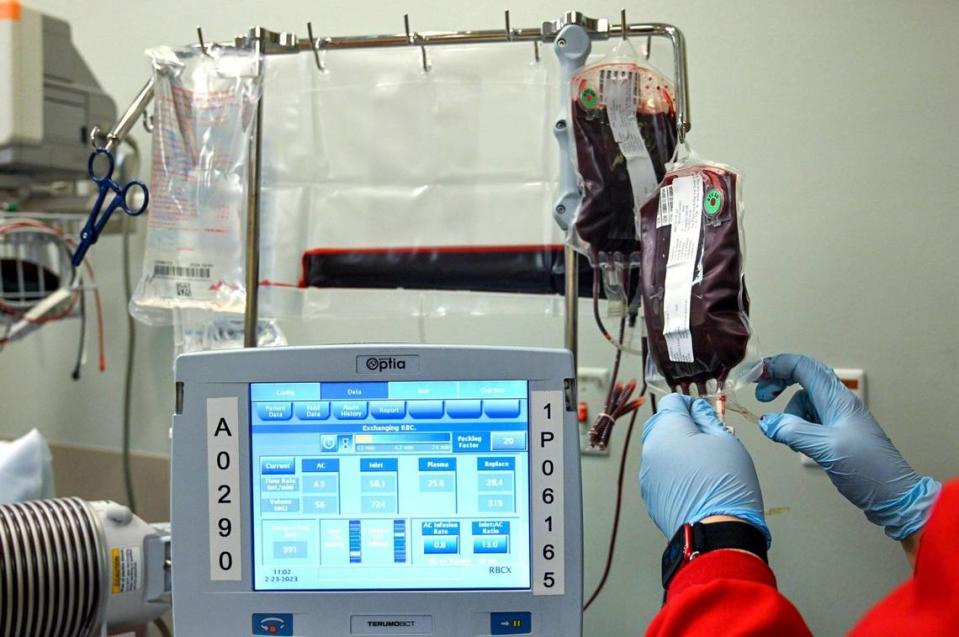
[91,9,691,357]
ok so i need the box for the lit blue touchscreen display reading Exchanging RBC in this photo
[250,380,530,590]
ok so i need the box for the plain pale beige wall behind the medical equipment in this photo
[0,0,959,636]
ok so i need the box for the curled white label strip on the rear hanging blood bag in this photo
[603,71,659,210]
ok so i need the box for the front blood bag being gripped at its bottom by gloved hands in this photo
[638,153,762,395]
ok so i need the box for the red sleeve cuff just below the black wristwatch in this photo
[646,550,812,637]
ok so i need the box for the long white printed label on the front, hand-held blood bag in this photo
[657,175,703,363]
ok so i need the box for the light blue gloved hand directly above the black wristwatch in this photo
[639,394,770,546]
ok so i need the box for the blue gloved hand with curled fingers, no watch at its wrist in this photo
[756,354,942,540]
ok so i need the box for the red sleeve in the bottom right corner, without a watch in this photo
[851,480,959,637]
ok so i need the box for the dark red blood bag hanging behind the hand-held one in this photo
[569,40,676,266]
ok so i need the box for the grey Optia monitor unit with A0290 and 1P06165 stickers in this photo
[172,346,582,637]
